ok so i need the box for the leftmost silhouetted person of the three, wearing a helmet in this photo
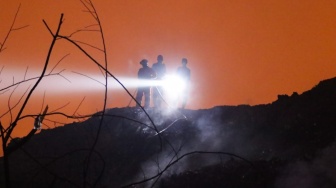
[135,59,156,108]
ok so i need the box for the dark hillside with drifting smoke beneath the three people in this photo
[0,78,336,188]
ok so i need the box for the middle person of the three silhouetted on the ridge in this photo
[152,55,166,108]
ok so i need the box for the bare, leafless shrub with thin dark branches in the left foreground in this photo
[0,0,249,187]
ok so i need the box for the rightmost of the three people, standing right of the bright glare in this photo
[177,58,190,109]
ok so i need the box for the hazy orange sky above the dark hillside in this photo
[0,0,336,152]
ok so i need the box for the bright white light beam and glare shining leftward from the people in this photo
[0,69,186,105]
